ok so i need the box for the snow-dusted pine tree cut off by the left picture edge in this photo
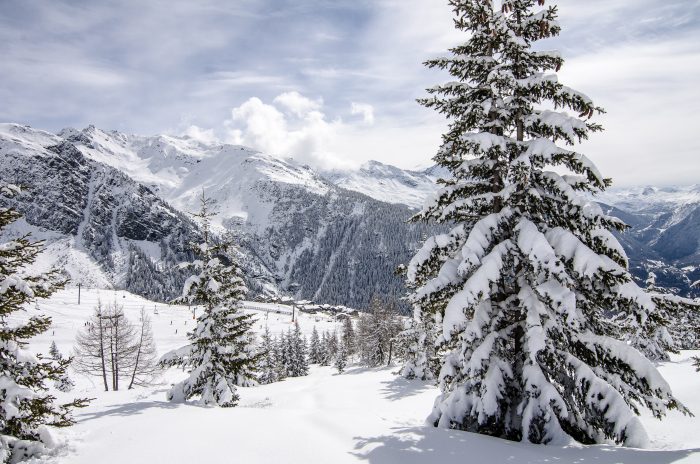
[0,184,88,463]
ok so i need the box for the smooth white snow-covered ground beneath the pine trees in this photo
[13,289,700,464]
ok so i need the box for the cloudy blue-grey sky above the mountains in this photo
[0,0,700,185]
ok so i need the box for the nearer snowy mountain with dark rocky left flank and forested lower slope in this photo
[0,126,427,308]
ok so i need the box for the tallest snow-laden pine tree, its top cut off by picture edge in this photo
[407,0,685,446]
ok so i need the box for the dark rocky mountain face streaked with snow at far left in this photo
[0,126,199,299]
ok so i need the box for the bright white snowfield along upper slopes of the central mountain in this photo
[59,126,330,227]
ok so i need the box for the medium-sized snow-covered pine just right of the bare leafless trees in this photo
[161,192,258,407]
